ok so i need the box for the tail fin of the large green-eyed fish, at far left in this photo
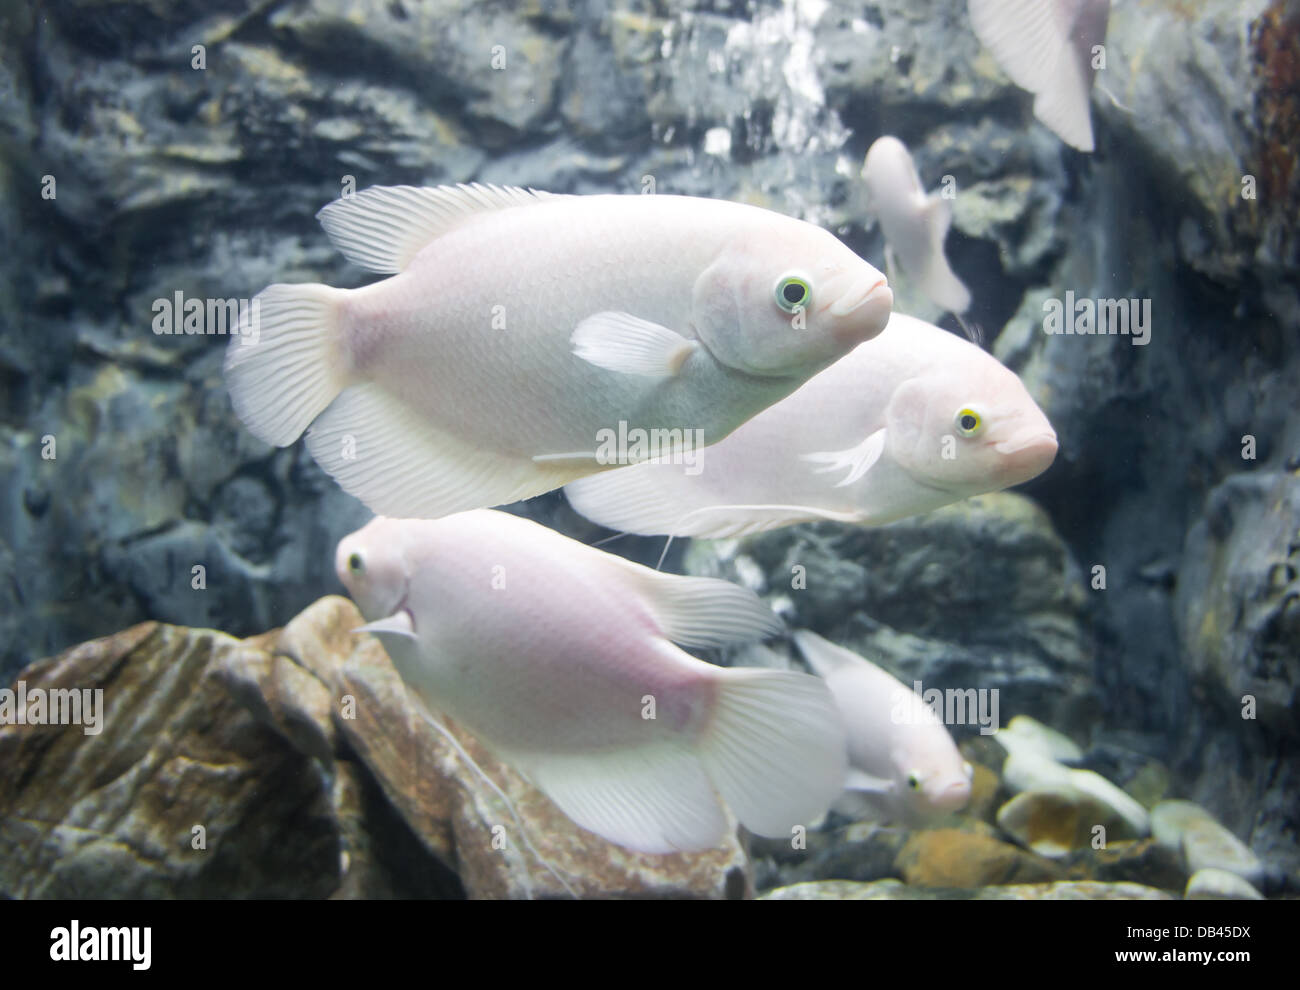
[225,283,348,447]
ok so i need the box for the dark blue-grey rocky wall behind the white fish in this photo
[0,0,1300,874]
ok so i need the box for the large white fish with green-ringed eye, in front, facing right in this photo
[226,186,893,517]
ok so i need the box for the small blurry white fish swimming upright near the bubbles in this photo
[862,135,971,314]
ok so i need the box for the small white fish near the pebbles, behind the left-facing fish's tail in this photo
[794,629,974,825]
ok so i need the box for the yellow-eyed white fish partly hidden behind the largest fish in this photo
[566,313,1057,537]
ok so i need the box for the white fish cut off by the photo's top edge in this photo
[970,0,1110,152]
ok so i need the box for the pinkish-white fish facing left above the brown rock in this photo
[335,509,846,852]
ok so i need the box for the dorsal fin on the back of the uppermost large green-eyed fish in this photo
[316,183,551,275]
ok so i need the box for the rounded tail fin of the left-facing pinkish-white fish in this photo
[699,668,848,838]
